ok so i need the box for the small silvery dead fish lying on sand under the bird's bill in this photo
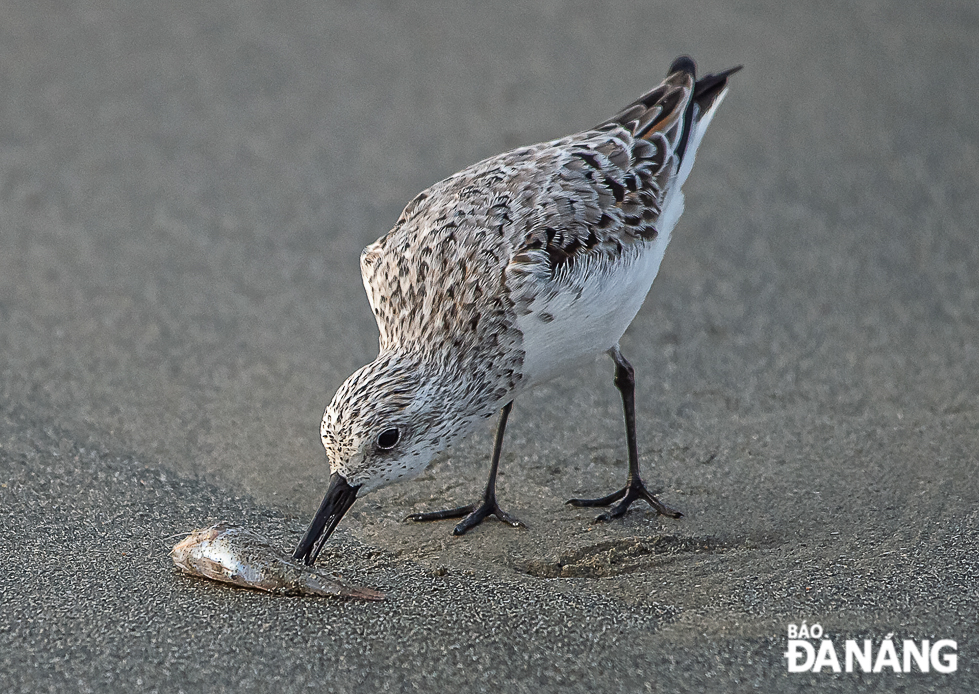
[170,523,384,600]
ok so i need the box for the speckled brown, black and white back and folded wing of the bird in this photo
[361,59,728,358]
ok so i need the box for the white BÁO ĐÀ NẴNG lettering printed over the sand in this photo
[785,622,959,674]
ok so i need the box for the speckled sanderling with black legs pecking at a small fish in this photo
[295,57,740,564]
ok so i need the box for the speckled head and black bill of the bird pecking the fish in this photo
[294,354,479,564]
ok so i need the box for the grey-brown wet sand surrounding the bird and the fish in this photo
[0,2,979,692]
